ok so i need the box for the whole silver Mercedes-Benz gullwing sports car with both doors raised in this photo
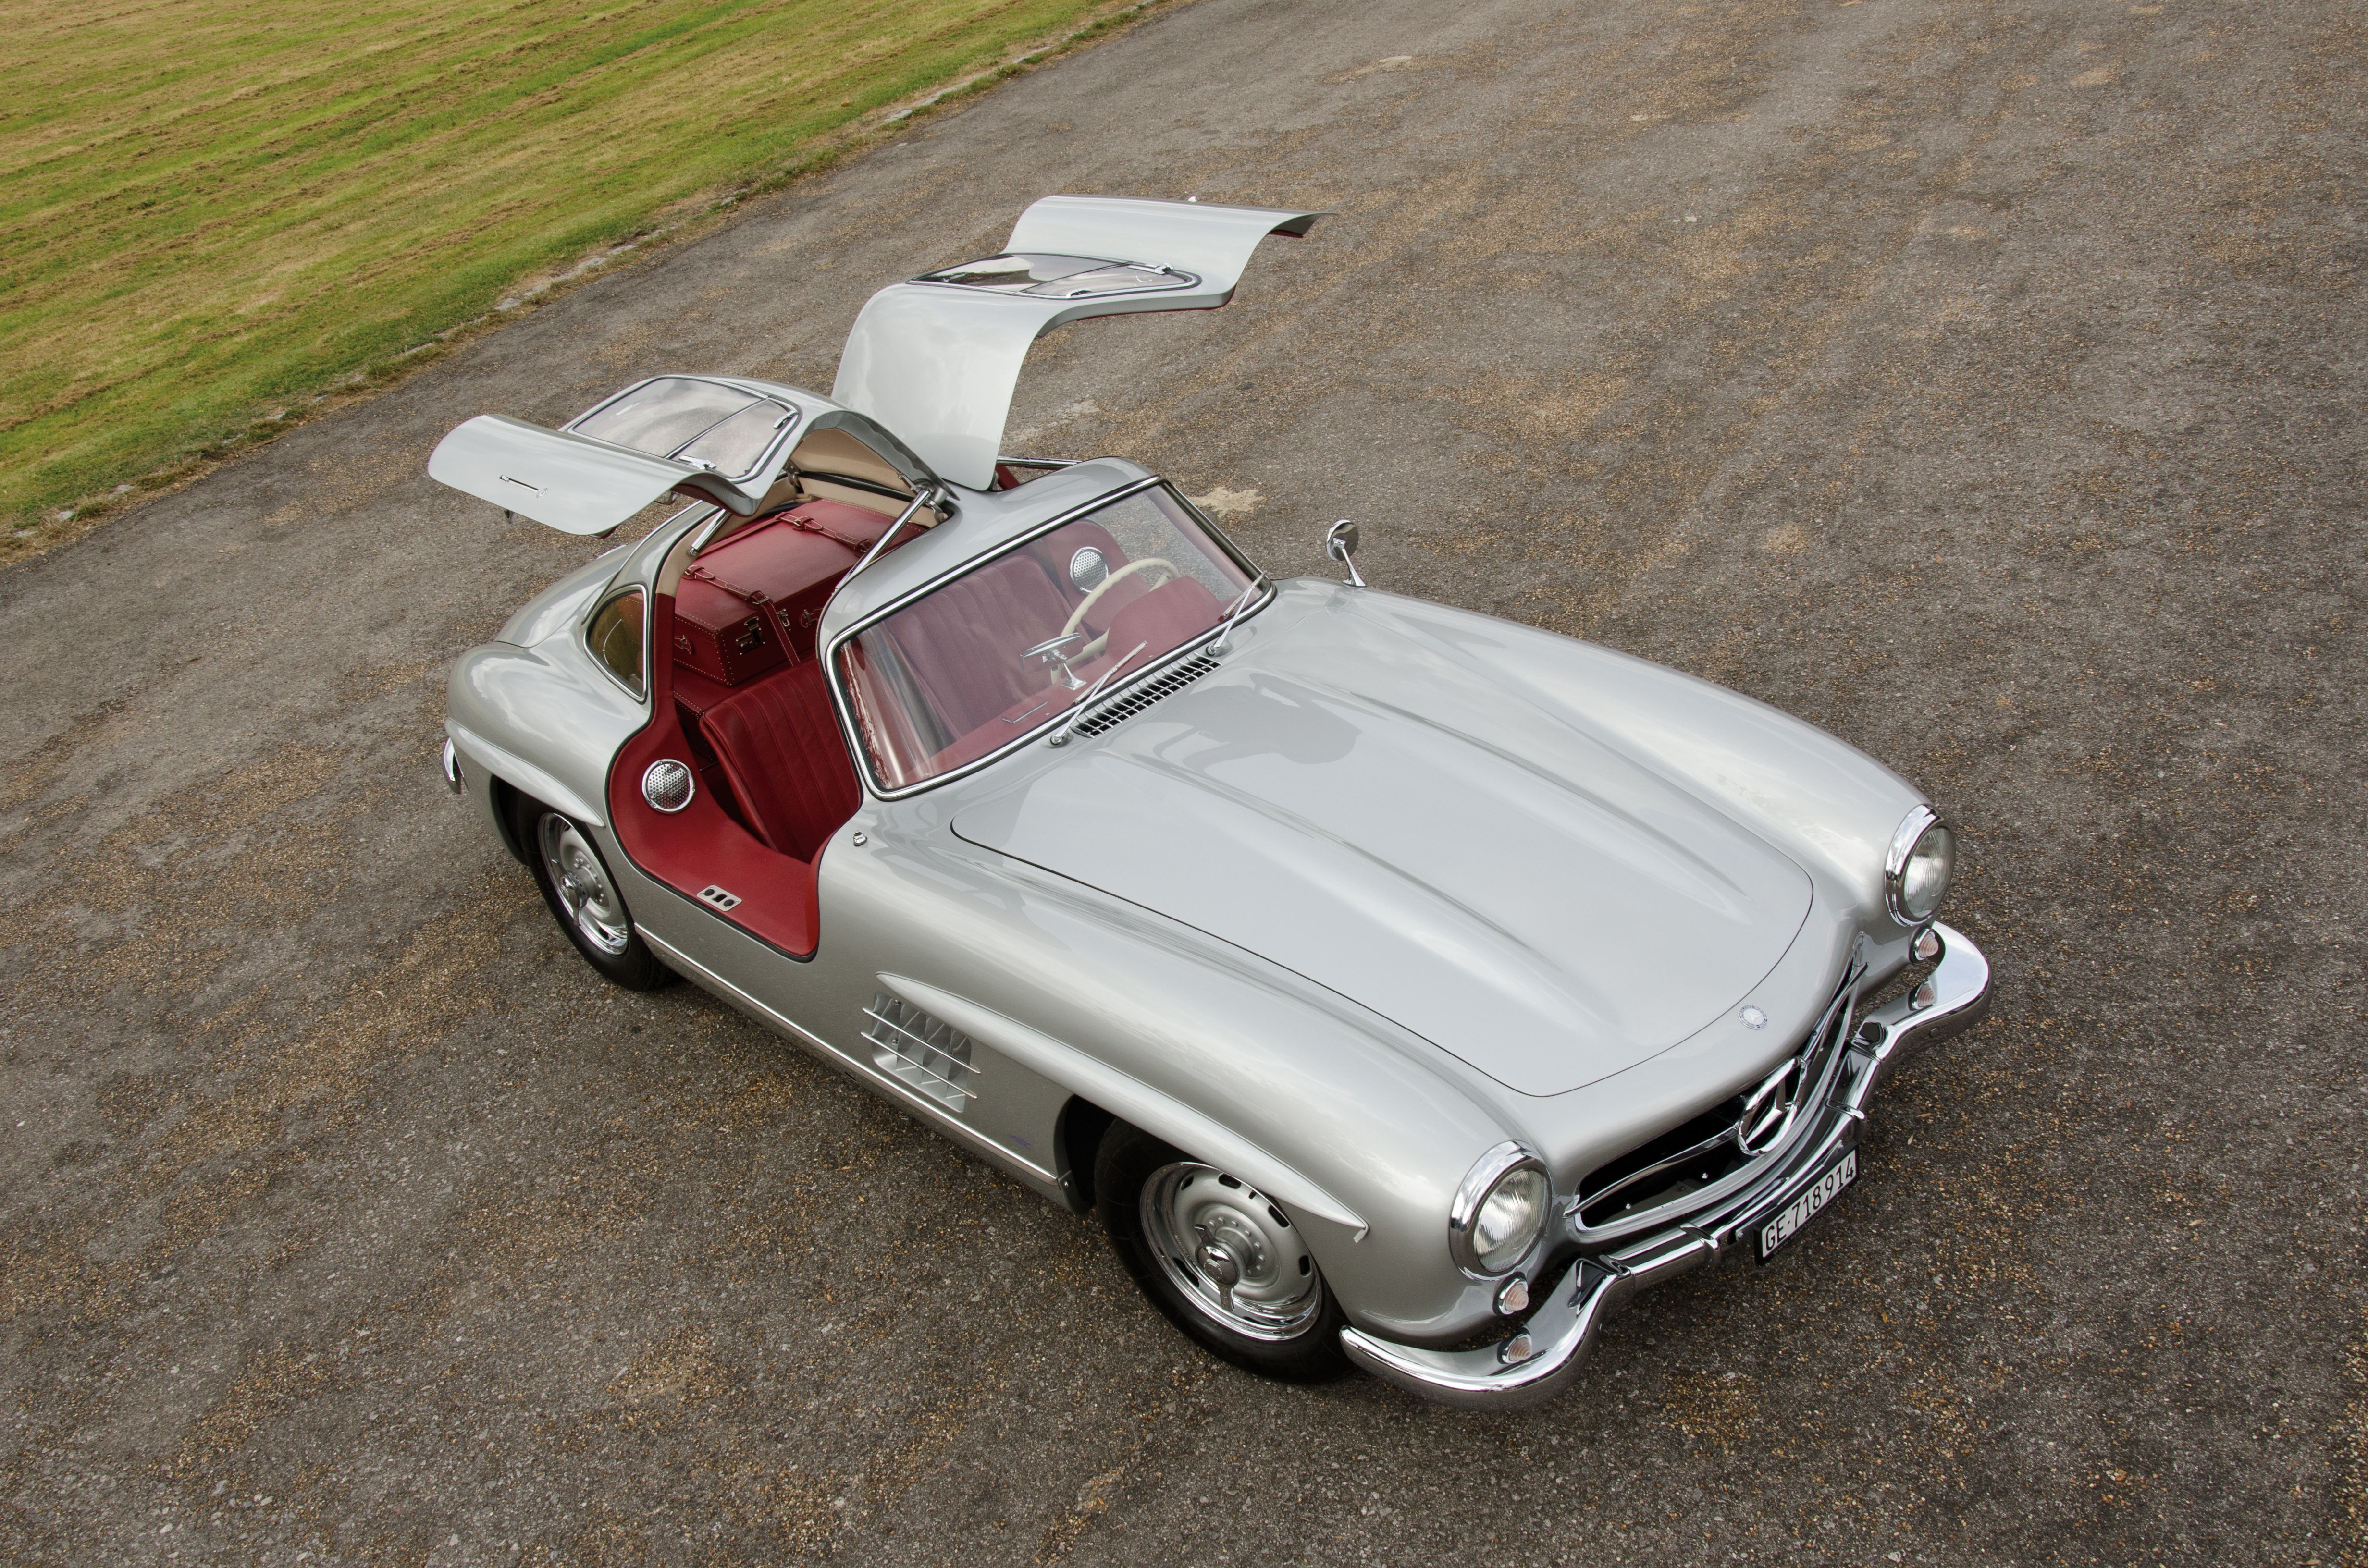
[429,196,1989,1407]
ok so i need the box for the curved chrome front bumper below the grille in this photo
[1340,924,1989,1409]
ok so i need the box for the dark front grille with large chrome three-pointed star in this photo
[1572,973,1857,1232]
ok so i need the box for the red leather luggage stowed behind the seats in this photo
[675,500,890,687]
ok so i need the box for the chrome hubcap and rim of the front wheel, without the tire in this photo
[1141,1161,1324,1341]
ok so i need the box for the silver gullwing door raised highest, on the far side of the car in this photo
[831,196,1324,490]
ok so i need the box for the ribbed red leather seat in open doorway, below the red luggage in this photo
[699,659,862,860]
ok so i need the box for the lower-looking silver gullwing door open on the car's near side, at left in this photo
[429,377,936,533]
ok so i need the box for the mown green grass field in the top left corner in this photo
[0,0,1132,528]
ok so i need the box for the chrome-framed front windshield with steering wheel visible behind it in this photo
[839,486,1250,789]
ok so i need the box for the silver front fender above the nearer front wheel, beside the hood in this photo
[822,829,1523,1341]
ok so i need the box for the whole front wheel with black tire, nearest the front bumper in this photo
[1094,1123,1350,1383]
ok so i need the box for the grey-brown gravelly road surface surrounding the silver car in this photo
[0,0,2368,1568]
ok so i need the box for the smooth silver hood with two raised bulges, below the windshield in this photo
[952,597,1812,1094]
